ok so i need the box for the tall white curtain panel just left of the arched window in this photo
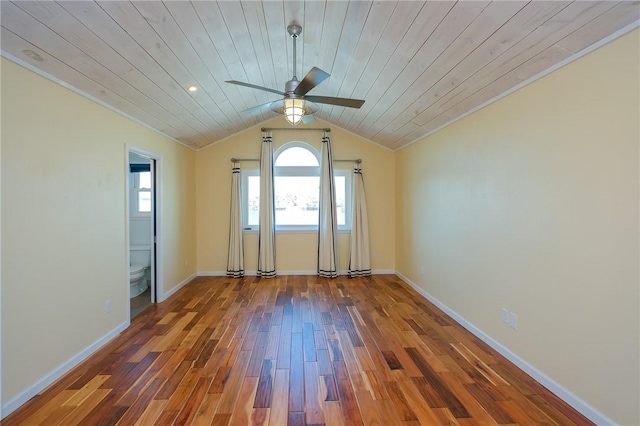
[257,133,276,278]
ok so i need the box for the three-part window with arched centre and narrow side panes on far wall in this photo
[244,142,351,231]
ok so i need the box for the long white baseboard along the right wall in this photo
[395,271,615,425]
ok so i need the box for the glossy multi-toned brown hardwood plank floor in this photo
[2,275,591,426]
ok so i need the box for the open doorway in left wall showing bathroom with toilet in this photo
[127,148,159,321]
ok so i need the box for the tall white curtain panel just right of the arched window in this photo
[318,133,338,278]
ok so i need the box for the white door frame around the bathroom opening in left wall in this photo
[125,144,163,324]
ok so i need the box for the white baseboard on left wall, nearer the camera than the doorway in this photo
[2,322,129,418]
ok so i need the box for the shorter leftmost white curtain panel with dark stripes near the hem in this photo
[227,162,244,278]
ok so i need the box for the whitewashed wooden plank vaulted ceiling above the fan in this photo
[0,0,640,150]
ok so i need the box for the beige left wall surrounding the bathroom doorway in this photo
[2,59,195,404]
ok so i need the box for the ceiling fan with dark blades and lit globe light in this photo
[226,24,364,125]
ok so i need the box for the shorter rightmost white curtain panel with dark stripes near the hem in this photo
[349,164,371,277]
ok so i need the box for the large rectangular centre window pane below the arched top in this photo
[274,176,320,225]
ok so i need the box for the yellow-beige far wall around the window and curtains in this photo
[196,118,395,273]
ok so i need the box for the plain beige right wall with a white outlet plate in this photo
[396,30,640,425]
